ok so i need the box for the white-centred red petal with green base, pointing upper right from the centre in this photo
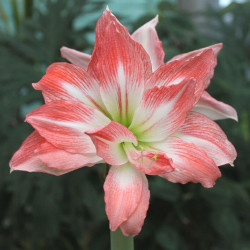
[129,79,196,142]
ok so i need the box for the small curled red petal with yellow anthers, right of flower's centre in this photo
[124,143,173,175]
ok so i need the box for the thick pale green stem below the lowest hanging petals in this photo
[110,228,134,250]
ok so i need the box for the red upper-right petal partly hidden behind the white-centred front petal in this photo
[146,49,216,101]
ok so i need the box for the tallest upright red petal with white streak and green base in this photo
[88,10,151,125]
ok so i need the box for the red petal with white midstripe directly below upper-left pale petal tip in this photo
[33,63,105,112]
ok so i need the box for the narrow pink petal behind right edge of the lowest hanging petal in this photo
[120,172,150,237]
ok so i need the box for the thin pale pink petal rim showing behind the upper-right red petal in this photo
[168,43,223,87]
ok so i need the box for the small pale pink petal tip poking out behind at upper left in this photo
[61,47,91,70]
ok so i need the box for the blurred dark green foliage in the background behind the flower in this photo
[0,0,250,250]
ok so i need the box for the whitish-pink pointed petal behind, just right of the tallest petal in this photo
[132,16,165,71]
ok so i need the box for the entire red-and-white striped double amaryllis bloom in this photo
[10,10,237,236]
